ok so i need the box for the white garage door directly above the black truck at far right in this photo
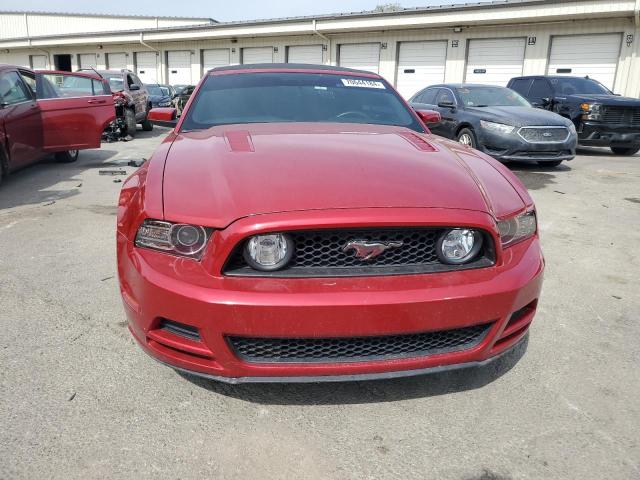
[548,33,622,90]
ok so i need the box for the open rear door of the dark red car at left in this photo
[36,71,115,152]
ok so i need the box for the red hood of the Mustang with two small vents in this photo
[163,123,524,228]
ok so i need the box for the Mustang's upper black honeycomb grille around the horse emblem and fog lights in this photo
[224,228,493,277]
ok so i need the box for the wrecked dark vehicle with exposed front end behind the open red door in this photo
[85,70,153,136]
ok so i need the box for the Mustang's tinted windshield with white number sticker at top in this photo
[182,73,424,132]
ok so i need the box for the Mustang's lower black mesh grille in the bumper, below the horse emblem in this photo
[228,324,491,363]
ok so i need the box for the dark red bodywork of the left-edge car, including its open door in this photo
[0,65,115,171]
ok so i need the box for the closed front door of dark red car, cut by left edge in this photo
[0,70,42,170]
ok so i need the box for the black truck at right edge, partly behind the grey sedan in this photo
[507,76,640,155]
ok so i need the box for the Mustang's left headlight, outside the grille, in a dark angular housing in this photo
[135,220,211,260]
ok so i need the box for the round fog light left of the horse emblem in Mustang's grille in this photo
[244,233,294,272]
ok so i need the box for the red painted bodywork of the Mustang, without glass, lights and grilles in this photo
[117,69,544,382]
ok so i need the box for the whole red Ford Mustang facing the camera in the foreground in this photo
[117,65,544,383]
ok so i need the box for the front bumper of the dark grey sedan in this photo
[477,128,577,162]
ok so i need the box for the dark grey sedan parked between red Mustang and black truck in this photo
[409,84,577,166]
